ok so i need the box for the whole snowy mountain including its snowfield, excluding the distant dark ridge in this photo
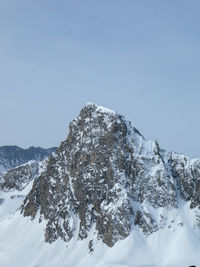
[0,103,200,267]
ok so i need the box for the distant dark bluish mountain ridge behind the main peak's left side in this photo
[0,146,57,174]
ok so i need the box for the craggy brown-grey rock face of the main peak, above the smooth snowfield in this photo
[21,103,200,250]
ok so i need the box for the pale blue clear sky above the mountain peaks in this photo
[0,0,200,157]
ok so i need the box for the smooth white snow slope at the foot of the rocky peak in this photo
[0,194,200,267]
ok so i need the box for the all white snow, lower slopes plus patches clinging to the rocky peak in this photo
[0,103,200,267]
